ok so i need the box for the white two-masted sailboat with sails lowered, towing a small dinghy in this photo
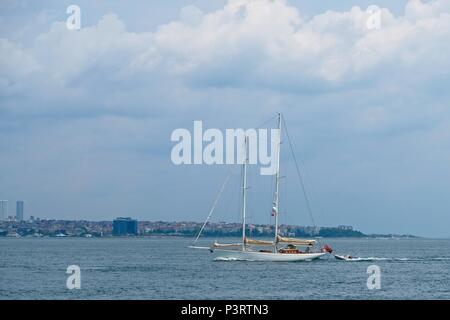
[192,113,331,262]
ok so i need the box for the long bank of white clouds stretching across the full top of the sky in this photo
[1,0,450,96]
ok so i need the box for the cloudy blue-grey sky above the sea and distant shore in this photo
[0,0,450,237]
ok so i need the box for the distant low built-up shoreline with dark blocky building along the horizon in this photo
[0,218,422,238]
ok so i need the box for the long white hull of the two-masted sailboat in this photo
[212,249,326,262]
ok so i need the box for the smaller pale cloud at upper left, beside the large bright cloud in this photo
[31,14,149,85]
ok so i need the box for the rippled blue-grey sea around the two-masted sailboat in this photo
[0,238,450,299]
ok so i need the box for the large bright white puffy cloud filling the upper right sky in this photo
[134,0,450,90]
